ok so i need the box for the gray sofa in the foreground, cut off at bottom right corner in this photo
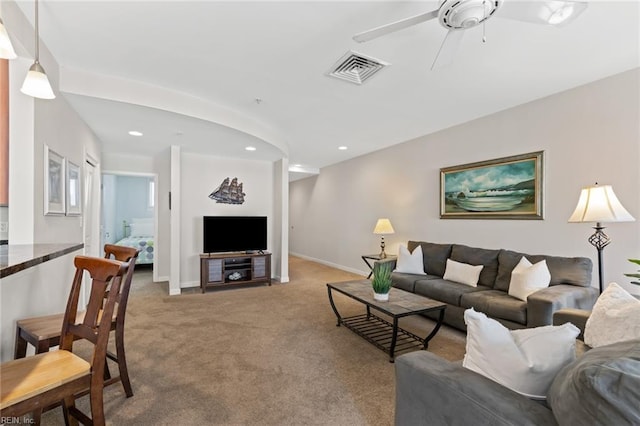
[395,310,640,426]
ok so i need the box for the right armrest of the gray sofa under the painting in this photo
[527,284,598,327]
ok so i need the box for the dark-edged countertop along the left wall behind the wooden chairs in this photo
[0,243,84,278]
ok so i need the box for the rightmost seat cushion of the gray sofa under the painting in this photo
[460,290,527,325]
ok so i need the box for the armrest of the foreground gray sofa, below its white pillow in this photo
[395,351,557,426]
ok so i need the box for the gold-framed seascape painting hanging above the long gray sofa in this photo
[440,151,543,219]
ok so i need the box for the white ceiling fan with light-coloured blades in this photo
[353,0,587,70]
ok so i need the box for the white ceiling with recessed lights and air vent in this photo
[11,0,640,179]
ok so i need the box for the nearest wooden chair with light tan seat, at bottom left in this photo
[0,256,128,426]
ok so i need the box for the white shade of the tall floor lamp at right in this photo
[569,185,635,222]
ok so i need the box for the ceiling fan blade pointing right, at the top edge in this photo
[496,0,587,27]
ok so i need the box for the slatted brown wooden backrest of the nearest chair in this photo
[60,256,128,384]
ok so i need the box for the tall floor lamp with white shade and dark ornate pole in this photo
[569,183,635,293]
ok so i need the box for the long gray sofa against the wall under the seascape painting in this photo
[380,241,598,330]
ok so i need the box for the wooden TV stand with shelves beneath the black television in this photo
[200,252,271,293]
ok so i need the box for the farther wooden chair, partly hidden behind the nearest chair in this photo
[14,244,138,398]
